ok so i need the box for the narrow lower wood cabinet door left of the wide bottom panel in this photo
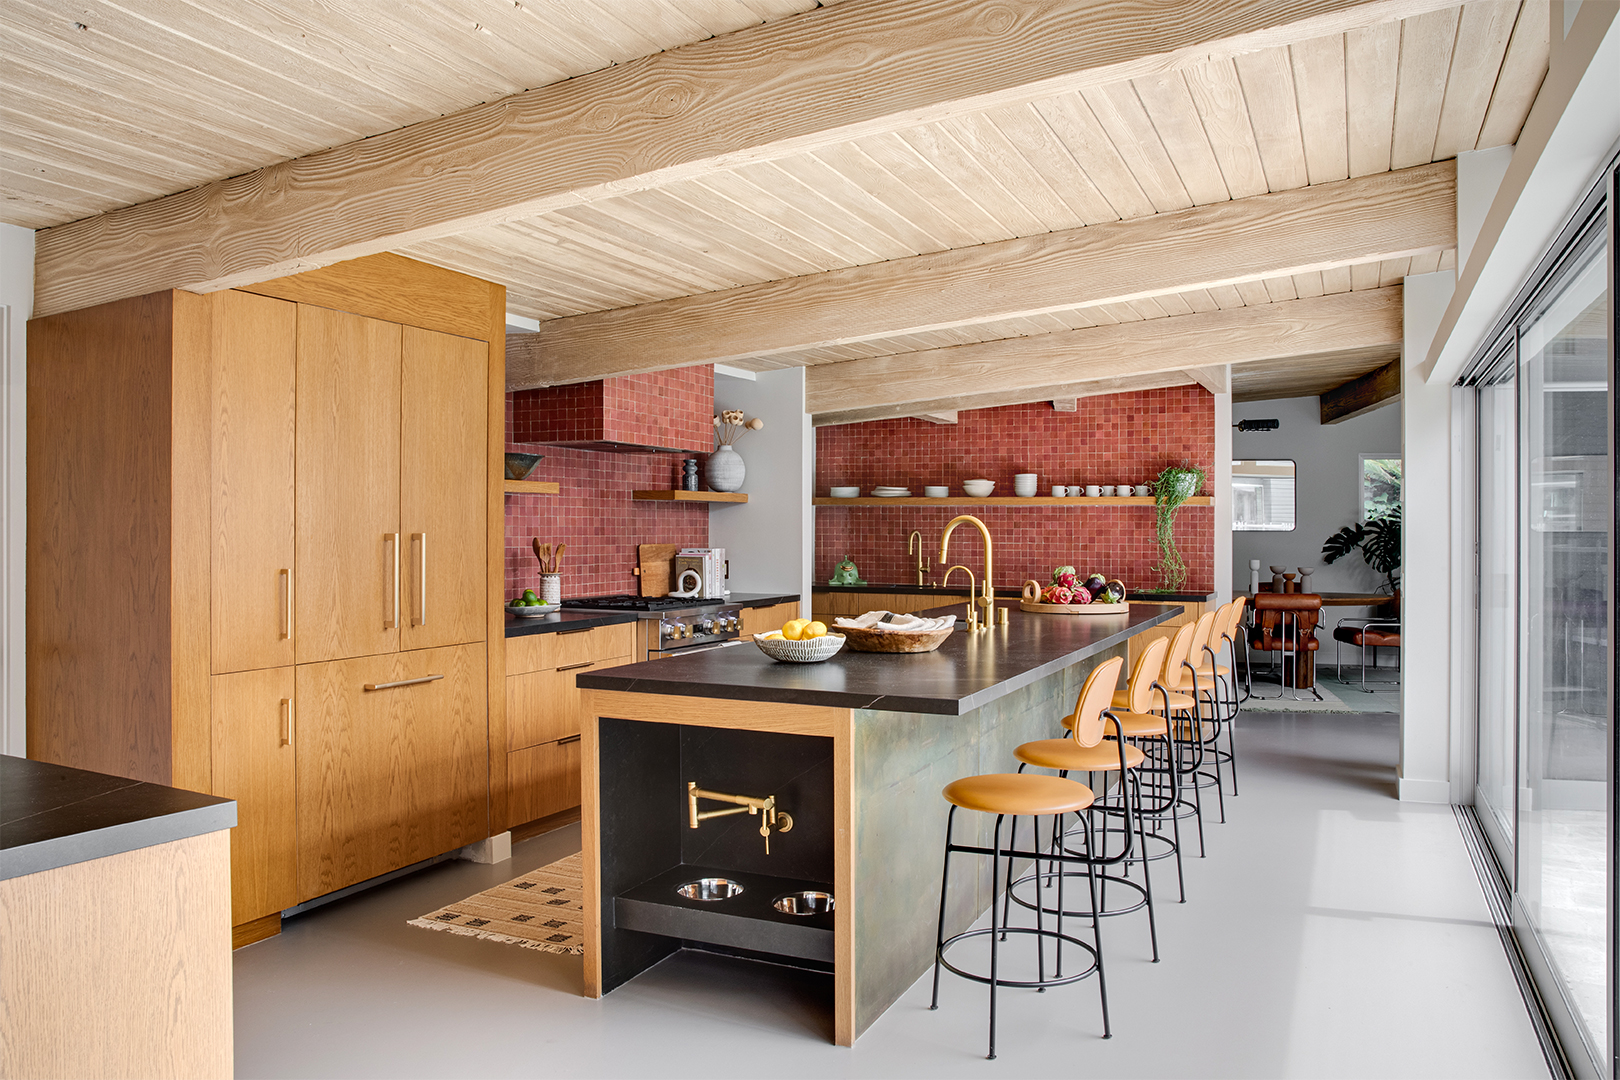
[212,665,300,926]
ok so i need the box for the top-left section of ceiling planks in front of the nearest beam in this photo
[0,0,816,228]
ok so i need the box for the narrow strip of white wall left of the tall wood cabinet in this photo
[0,225,34,758]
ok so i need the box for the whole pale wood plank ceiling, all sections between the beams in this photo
[0,0,1549,419]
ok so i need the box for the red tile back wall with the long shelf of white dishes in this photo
[815,387,1215,591]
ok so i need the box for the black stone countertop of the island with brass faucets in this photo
[575,604,1183,716]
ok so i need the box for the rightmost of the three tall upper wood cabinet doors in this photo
[399,327,489,649]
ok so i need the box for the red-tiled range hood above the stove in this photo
[509,364,714,453]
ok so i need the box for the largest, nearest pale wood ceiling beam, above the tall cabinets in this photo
[34,0,1455,314]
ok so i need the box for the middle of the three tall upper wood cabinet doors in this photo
[293,304,401,664]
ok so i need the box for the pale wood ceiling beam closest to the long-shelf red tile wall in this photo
[805,285,1401,413]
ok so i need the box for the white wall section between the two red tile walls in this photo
[710,368,815,617]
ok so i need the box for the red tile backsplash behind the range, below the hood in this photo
[505,395,713,597]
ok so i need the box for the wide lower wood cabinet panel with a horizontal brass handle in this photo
[298,644,489,900]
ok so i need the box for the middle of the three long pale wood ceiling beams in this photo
[507,162,1456,390]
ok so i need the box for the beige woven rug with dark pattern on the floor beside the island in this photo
[410,855,585,957]
